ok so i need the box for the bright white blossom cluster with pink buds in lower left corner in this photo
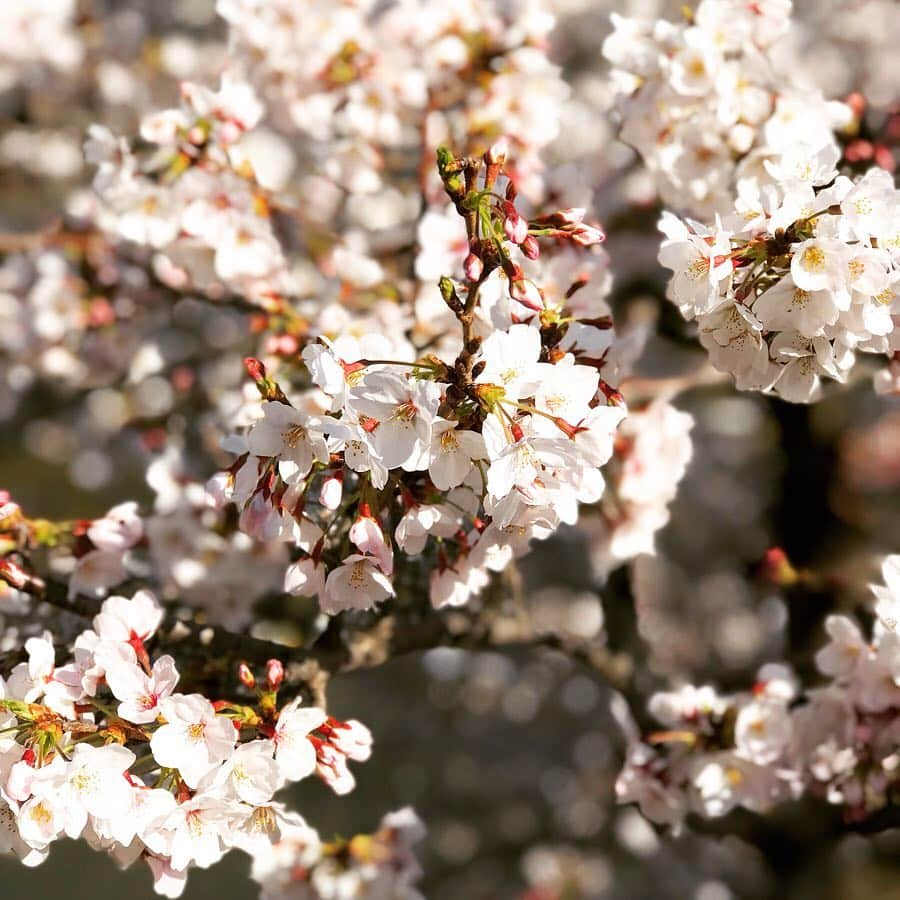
[0,591,372,897]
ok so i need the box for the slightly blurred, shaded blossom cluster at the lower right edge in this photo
[617,556,900,825]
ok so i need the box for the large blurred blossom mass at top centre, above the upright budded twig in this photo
[217,0,568,196]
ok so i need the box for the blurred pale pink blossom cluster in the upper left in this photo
[85,76,293,304]
